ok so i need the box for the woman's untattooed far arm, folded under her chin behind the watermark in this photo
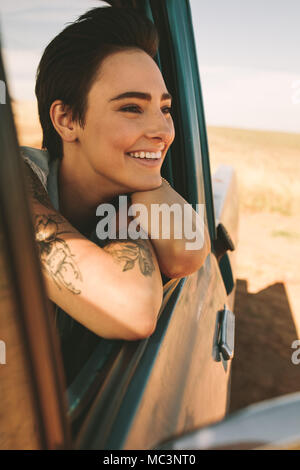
[131,180,210,278]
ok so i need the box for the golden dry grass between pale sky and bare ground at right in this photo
[208,127,300,215]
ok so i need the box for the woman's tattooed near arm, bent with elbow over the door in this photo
[24,163,162,340]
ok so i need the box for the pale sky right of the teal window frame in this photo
[190,0,300,133]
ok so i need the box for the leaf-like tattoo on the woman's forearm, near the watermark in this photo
[103,239,155,276]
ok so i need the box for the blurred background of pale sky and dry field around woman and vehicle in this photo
[0,0,300,410]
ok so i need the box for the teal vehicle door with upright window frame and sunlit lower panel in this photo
[71,0,238,449]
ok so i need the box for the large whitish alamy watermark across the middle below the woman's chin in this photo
[96,196,204,250]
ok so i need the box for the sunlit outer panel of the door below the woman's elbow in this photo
[124,256,230,449]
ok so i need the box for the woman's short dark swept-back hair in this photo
[35,7,158,159]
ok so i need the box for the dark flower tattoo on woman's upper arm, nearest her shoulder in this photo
[35,214,82,294]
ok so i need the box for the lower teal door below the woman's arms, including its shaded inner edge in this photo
[76,255,230,449]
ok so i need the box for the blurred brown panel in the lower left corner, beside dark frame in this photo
[0,217,42,450]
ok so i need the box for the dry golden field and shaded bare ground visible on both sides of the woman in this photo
[10,103,300,410]
